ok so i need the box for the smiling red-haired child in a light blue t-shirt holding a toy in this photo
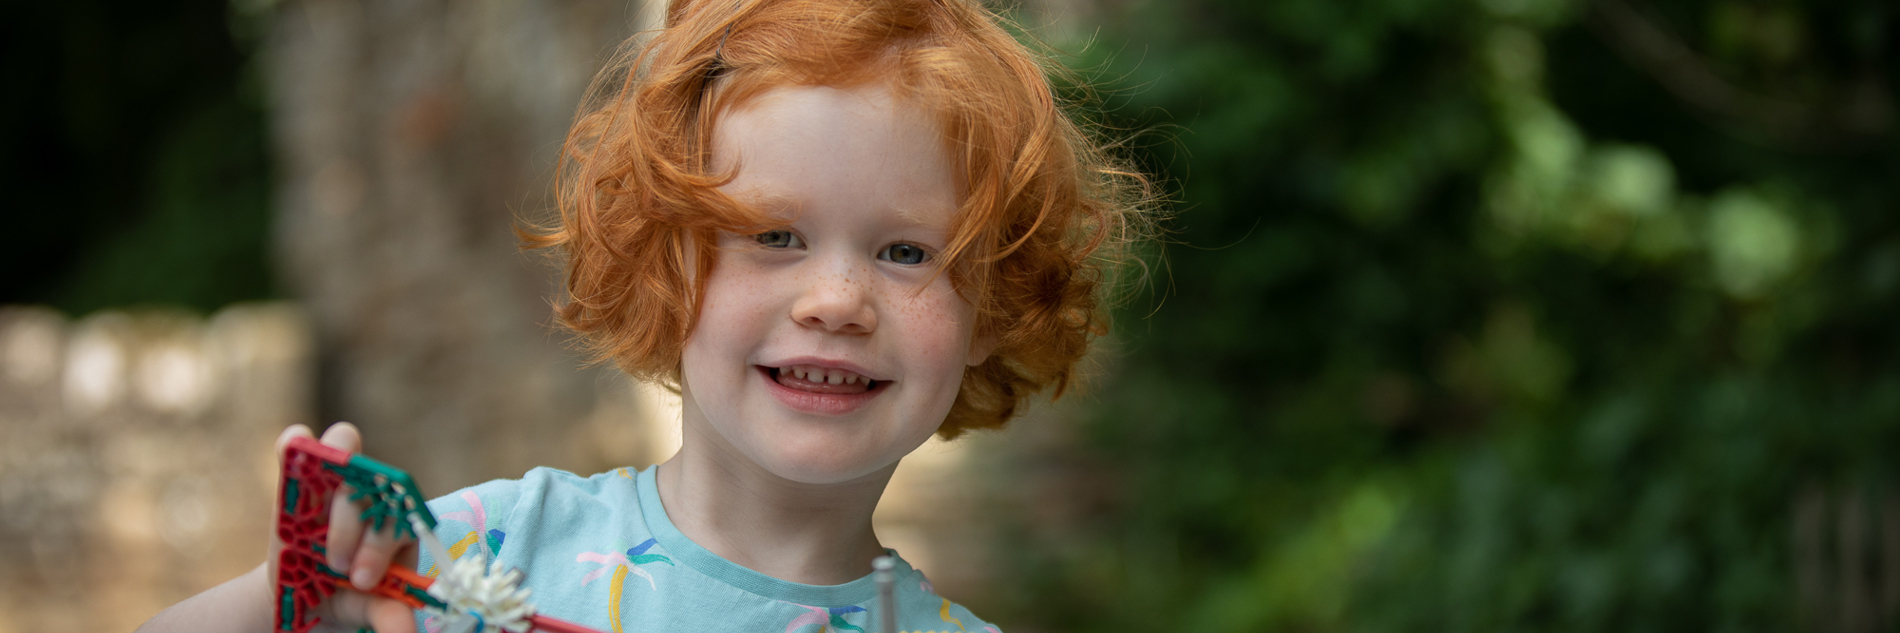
[148,0,1150,633]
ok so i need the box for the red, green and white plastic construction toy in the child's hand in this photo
[276,437,600,633]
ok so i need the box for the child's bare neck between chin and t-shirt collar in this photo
[656,404,897,585]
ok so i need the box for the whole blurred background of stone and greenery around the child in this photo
[0,0,1900,633]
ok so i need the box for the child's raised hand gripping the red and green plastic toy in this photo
[268,422,416,633]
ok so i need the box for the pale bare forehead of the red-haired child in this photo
[713,82,958,226]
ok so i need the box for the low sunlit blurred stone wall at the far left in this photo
[0,304,314,633]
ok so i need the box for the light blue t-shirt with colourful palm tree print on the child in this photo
[418,468,1001,633]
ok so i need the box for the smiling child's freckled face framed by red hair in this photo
[682,84,990,483]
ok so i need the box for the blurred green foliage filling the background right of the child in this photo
[992,0,1900,631]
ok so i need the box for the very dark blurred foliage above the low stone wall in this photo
[0,0,274,314]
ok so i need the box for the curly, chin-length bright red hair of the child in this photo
[523,0,1155,439]
